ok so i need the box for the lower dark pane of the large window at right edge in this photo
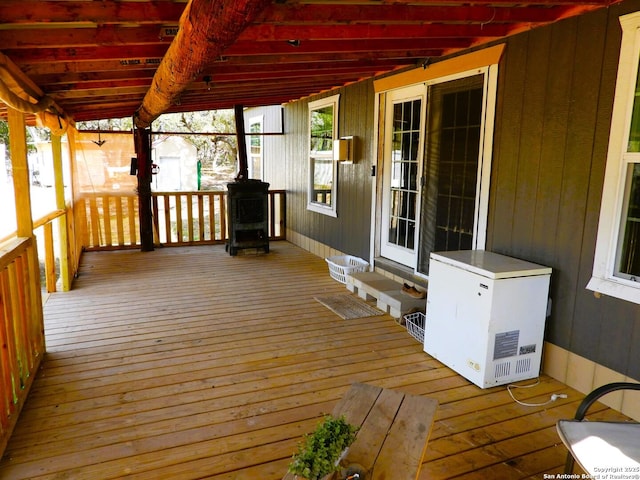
[619,163,640,280]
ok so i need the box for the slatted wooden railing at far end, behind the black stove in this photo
[81,190,286,250]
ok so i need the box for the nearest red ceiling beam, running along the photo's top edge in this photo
[0,0,603,28]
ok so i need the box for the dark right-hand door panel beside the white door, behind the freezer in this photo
[418,75,484,273]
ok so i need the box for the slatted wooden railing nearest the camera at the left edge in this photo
[0,238,44,452]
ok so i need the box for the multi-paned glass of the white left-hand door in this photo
[388,99,422,250]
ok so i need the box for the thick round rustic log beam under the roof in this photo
[134,0,271,128]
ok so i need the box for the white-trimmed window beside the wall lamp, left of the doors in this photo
[307,95,340,217]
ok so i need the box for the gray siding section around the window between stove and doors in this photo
[285,81,375,259]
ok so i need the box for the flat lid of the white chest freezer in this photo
[430,250,551,279]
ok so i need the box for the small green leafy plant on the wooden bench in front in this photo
[289,415,358,480]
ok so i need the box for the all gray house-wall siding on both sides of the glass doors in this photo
[285,0,640,378]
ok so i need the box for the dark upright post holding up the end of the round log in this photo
[134,128,153,252]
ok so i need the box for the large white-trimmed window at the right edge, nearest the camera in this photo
[587,12,640,303]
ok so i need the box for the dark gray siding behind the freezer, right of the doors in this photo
[487,1,640,378]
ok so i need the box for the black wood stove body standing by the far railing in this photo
[226,180,269,255]
